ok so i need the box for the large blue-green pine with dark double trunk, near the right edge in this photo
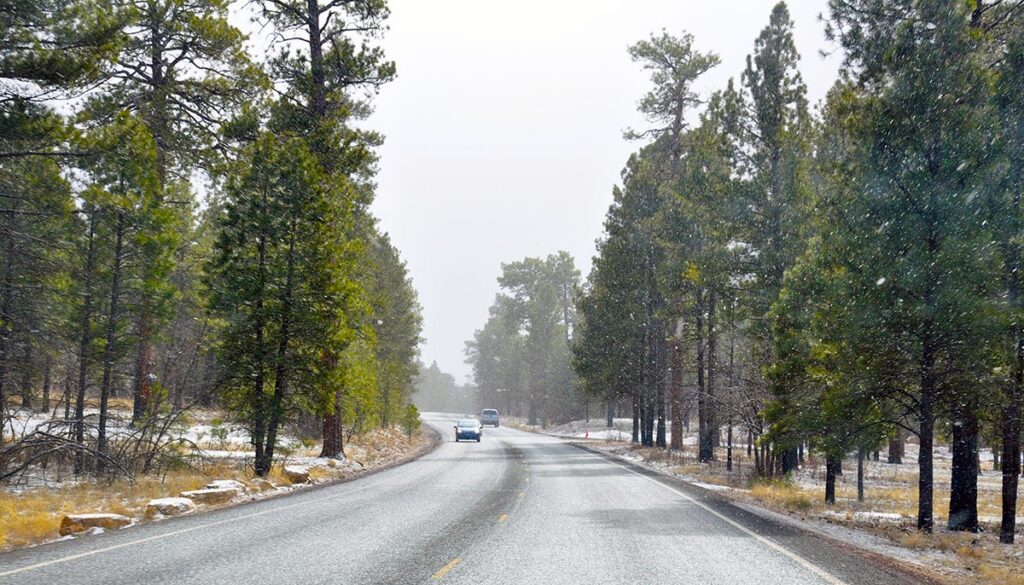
[831,1,994,531]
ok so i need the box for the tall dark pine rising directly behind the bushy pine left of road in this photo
[257,0,395,456]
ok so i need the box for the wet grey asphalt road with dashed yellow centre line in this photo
[0,415,929,585]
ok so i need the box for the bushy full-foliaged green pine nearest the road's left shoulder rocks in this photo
[208,133,359,475]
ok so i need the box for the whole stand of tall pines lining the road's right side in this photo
[573,0,1024,542]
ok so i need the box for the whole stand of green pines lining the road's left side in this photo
[0,0,421,475]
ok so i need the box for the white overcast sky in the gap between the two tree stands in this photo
[369,0,839,381]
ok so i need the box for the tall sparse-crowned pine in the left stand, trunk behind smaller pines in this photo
[83,0,262,422]
